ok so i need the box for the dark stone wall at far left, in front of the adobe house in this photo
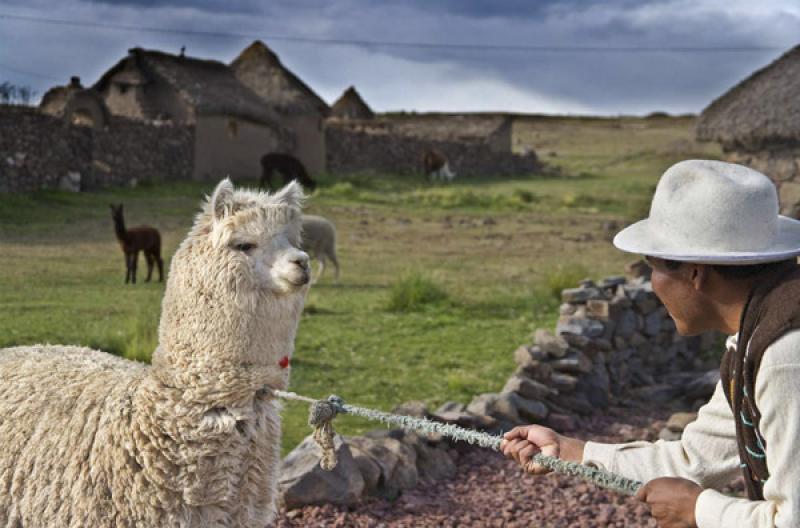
[0,106,194,192]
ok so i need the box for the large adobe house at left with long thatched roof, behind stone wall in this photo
[92,48,293,184]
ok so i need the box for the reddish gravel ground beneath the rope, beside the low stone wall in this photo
[276,409,680,528]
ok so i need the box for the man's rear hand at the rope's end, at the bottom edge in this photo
[636,477,703,528]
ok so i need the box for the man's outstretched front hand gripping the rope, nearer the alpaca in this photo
[500,425,584,475]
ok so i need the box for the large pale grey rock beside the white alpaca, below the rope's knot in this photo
[279,436,365,510]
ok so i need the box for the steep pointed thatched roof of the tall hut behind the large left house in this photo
[231,40,330,116]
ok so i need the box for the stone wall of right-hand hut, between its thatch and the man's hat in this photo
[726,147,800,218]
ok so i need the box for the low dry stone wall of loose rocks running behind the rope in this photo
[281,263,722,508]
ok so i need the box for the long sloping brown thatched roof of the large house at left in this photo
[93,48,277,124]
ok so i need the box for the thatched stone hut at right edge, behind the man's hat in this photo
[696,46,800,218]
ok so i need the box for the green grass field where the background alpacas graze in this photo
[0,113,719,451]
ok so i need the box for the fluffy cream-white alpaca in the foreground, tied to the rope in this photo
[0,179,309,527]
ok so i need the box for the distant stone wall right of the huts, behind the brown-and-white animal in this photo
[326,121,541,176]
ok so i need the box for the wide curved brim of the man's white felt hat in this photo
[614,216,800,265]
